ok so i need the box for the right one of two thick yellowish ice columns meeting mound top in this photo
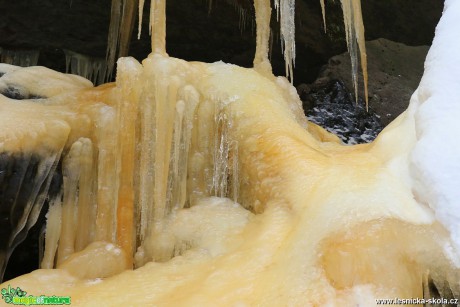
[254,0,272,76]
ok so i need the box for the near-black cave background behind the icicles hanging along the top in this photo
[0,0,443,83]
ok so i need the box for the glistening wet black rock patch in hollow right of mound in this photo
[299,80,383,145]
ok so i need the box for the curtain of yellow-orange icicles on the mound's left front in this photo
[42,63,238,268]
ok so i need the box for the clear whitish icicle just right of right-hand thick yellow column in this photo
[275,0,295,82]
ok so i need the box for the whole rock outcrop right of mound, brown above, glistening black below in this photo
[297,39,429,144]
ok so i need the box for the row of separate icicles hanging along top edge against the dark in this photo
[107,0,368,98]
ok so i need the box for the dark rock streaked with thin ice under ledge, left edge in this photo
[0,152,63,280]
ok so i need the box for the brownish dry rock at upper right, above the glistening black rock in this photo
[310,39,428,126]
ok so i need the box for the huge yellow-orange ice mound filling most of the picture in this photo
[0,0,459,306]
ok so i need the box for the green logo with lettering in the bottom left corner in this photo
[1,285,70,306]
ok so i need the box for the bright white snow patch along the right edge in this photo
[410,0,460,258]
